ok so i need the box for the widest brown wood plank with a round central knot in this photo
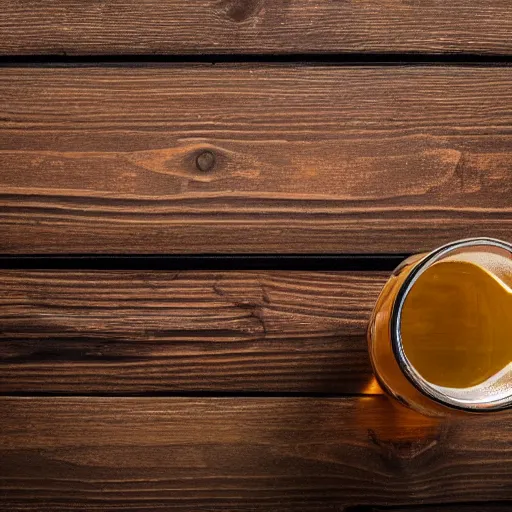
[0,65,512,253]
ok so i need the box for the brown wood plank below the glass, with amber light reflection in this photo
[0,396,512,511]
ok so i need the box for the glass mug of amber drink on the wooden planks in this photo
[368,238,512,416]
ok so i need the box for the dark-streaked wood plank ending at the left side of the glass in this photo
[0,271,388,394]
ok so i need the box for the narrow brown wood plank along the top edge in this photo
[0,0,512,55]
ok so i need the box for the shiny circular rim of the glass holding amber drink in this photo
[390,237,512,412]
